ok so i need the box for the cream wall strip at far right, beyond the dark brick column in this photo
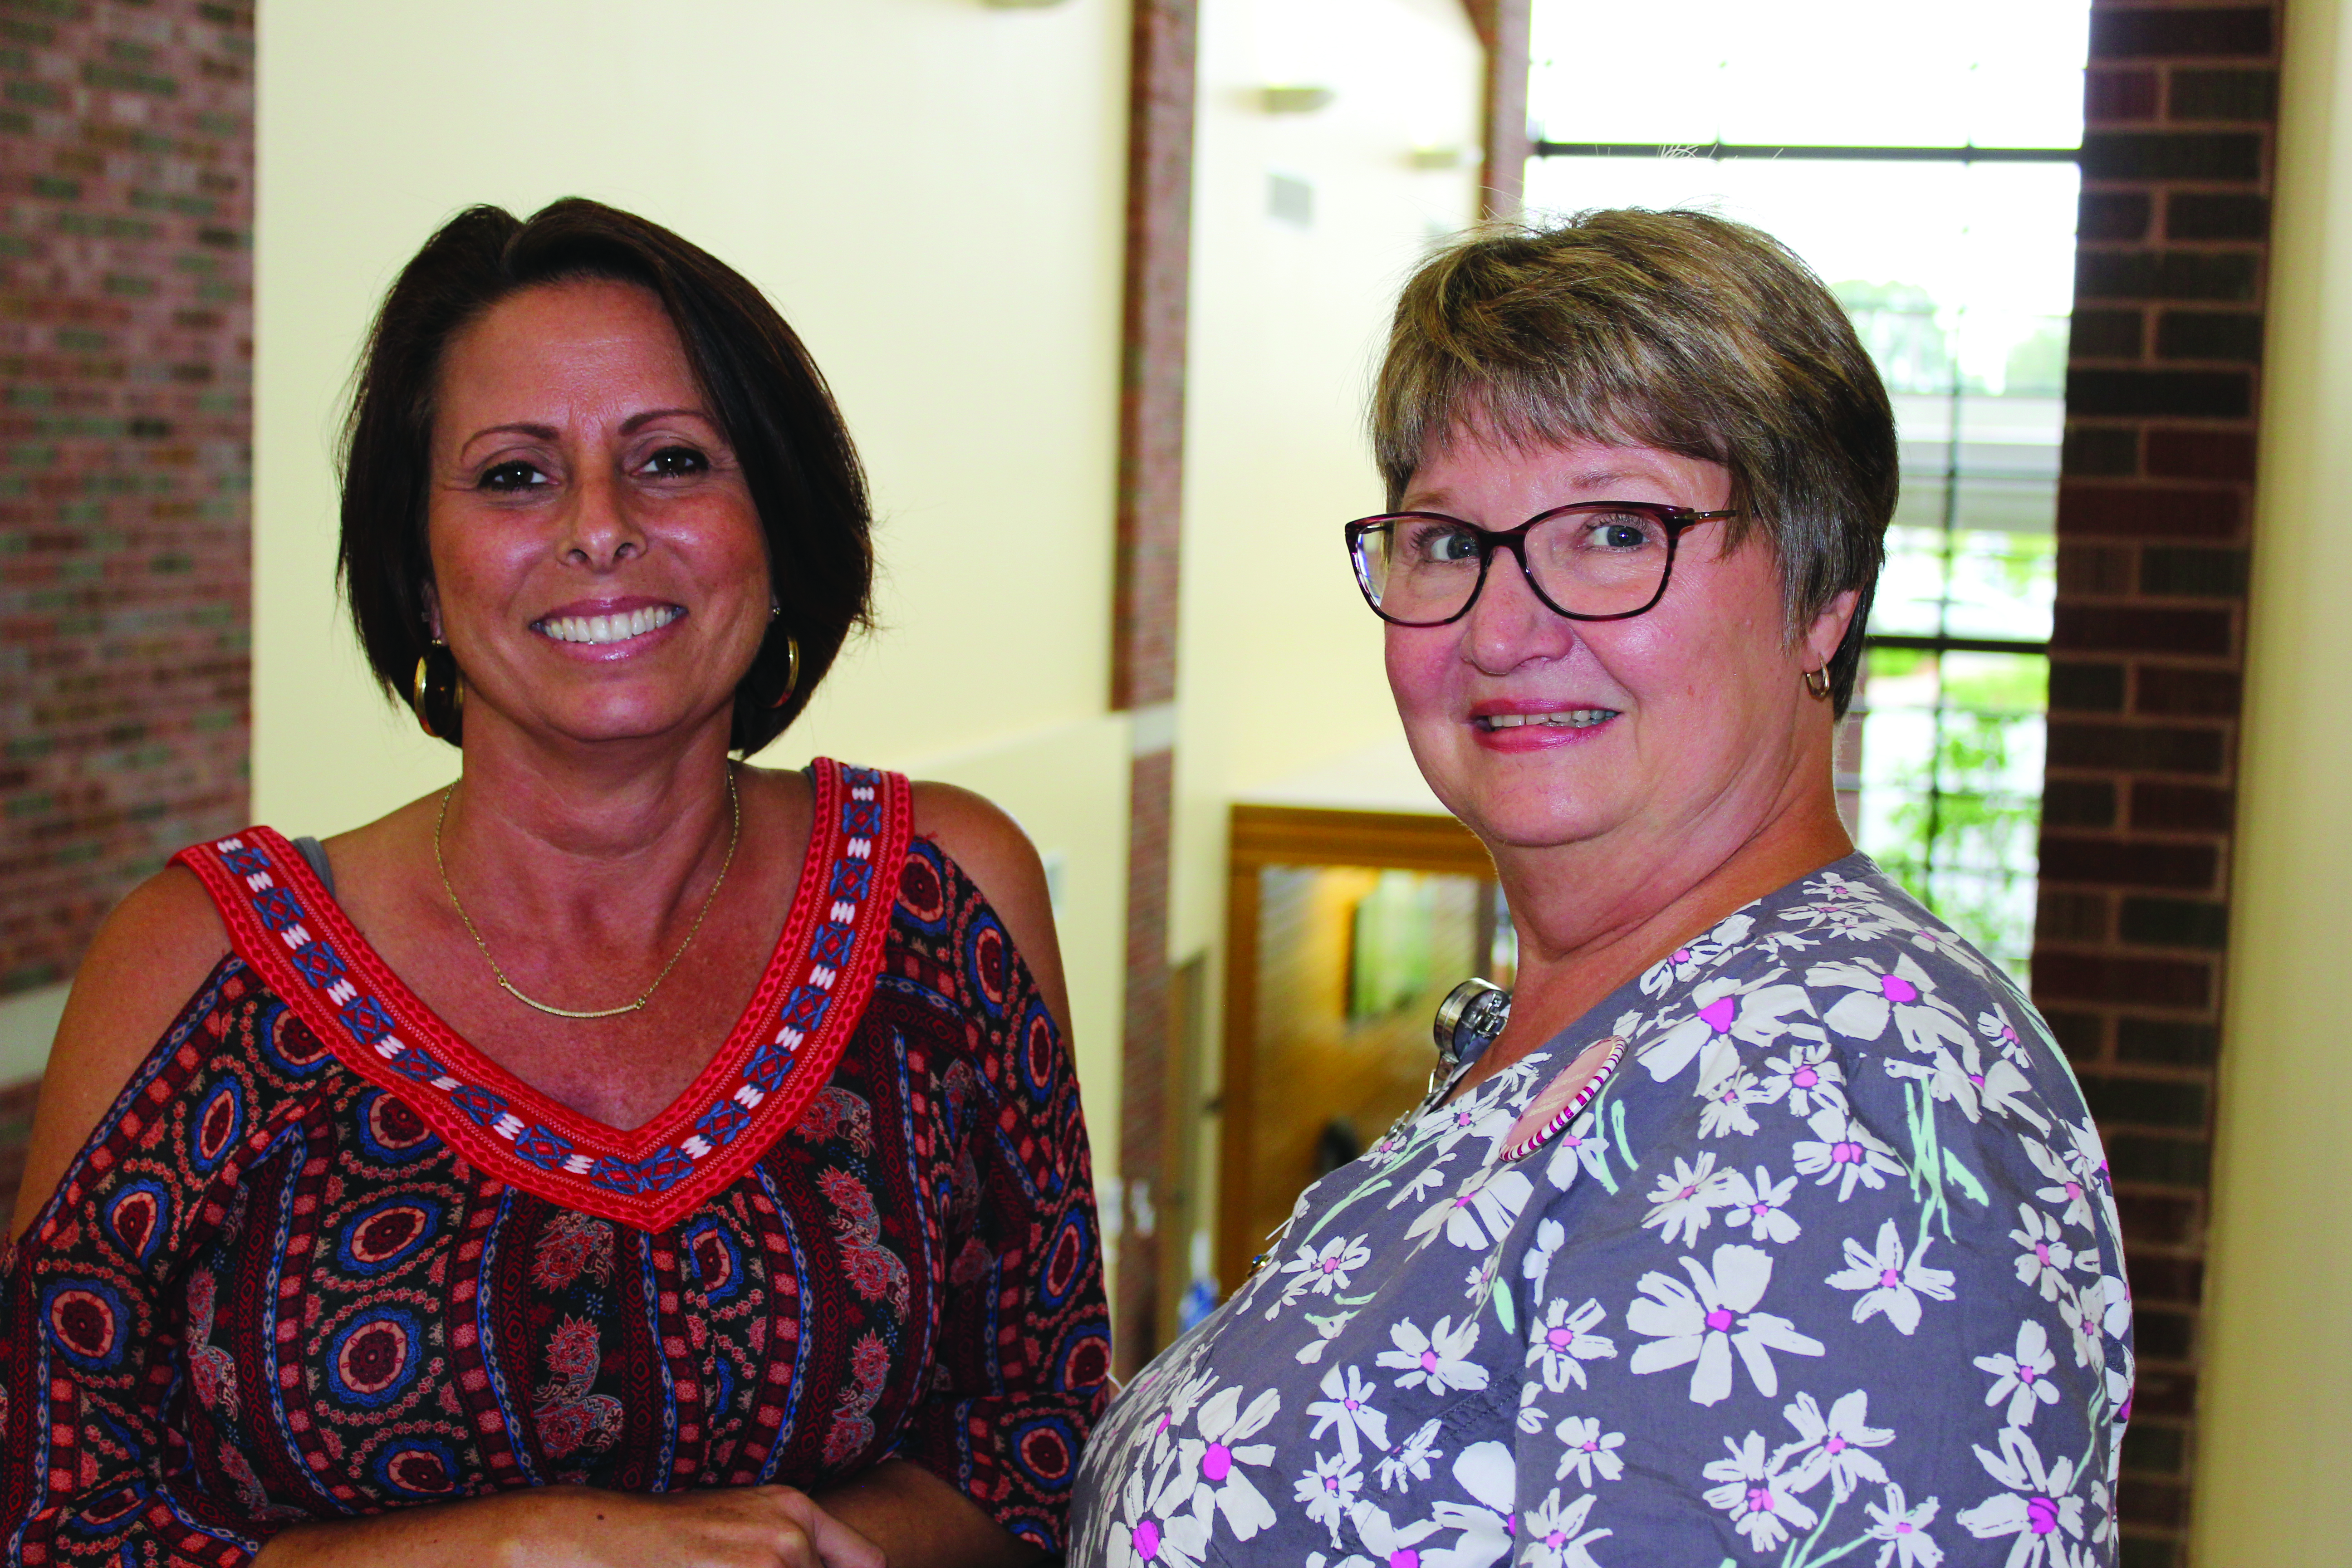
[2192,0,2352,1568]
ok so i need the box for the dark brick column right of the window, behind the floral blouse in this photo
[2032,0,2277,1568]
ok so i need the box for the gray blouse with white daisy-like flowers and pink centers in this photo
[1070,856,2131,1568]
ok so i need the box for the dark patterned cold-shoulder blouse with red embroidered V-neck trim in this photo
[0,760,1110,1568]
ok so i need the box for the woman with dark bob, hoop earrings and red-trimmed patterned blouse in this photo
[0,200,1108,1568]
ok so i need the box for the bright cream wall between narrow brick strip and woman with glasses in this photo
[1174,0,1482,952]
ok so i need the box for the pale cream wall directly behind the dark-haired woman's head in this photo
[254,0,1129,1171]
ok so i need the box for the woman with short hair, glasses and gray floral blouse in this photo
[1073,211,2131,1568]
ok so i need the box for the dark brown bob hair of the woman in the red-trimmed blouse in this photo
[341,197,872,752]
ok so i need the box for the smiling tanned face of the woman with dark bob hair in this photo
[426,280,769,740]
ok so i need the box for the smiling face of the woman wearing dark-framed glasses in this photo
[1388,430,1851,863]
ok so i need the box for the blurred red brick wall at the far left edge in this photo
[0,0,254,1001]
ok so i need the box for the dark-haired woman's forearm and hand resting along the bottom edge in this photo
[254,1486,887,1568]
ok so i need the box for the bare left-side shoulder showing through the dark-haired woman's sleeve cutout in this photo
[14,865,228,1234]
